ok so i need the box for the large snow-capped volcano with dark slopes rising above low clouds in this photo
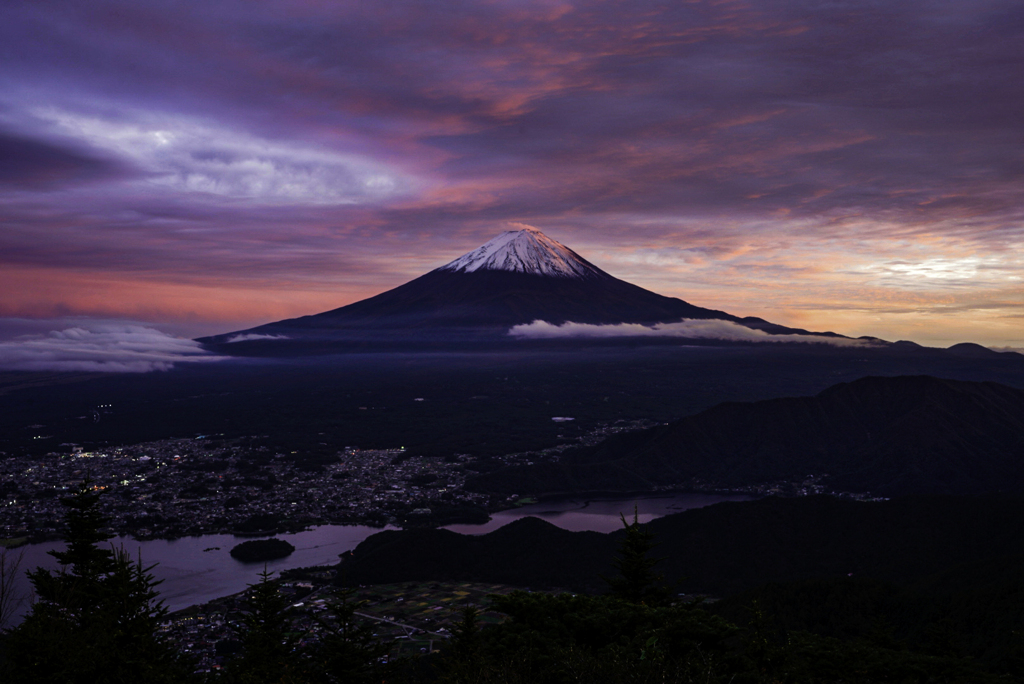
[200,227,846,352]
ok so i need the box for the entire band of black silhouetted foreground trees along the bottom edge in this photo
[0,487,1019,684]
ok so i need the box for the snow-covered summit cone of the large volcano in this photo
[437,226,602,277]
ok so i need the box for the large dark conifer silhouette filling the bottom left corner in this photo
[2,483,190,684]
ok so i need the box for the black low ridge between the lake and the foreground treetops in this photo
[339,496,1024,681]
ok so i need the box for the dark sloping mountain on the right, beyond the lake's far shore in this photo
[471,376,1024,496]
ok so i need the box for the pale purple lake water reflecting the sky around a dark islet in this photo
[2,494,754,622]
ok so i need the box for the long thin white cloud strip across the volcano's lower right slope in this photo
[509,318,872,347]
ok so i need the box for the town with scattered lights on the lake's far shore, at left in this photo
[0,438,489,541]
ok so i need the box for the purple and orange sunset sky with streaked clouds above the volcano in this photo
[0,0,1024,347]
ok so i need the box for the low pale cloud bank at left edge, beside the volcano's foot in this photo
[0,326,226,373]
